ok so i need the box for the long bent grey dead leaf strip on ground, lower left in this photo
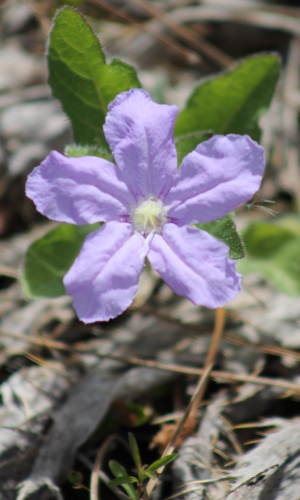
[18,364,174,500]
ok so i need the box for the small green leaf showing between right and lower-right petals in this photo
[196,214,245,259]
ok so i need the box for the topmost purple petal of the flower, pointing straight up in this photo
[104,89,178,201]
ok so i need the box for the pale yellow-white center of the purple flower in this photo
[132,198,167,234]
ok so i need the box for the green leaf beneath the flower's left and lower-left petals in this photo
[22,224,99,298]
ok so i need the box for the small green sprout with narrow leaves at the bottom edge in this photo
[108,432,177,500]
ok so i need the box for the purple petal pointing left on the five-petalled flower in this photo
[26,151,135,225]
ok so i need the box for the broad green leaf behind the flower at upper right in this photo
[175,55,280,141]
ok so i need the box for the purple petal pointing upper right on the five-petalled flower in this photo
[164,134,264,224]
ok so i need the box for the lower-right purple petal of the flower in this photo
[148,224,241,308]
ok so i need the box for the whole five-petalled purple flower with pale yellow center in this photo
[27,89,264,323]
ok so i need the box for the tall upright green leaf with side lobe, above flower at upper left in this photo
[48,8,140,145]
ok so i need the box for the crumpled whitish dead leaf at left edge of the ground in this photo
[0,362,75,500]
